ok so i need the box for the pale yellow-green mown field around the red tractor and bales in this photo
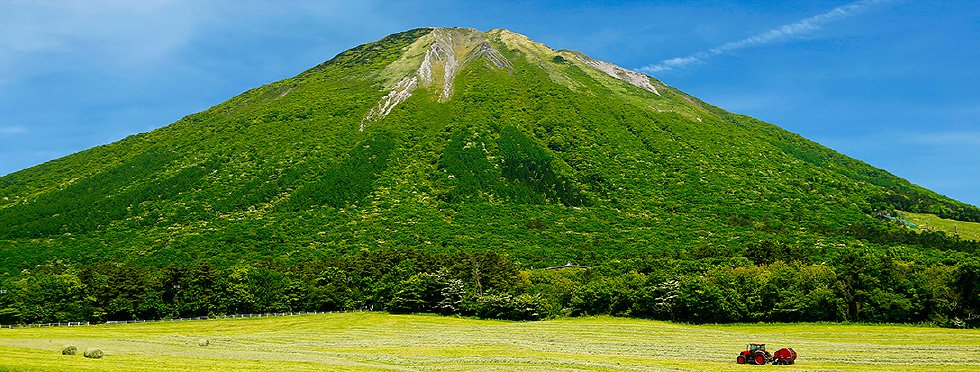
[0,313,980,371]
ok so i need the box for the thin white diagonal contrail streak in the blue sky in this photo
[639,0,889,73]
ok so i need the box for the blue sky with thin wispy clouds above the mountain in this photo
[0,0,980,205]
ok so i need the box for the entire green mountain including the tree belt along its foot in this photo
[0,29,980,326]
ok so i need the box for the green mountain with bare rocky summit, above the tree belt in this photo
[0,28,980,273]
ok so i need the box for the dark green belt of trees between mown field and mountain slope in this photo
[0,247,980,327]
